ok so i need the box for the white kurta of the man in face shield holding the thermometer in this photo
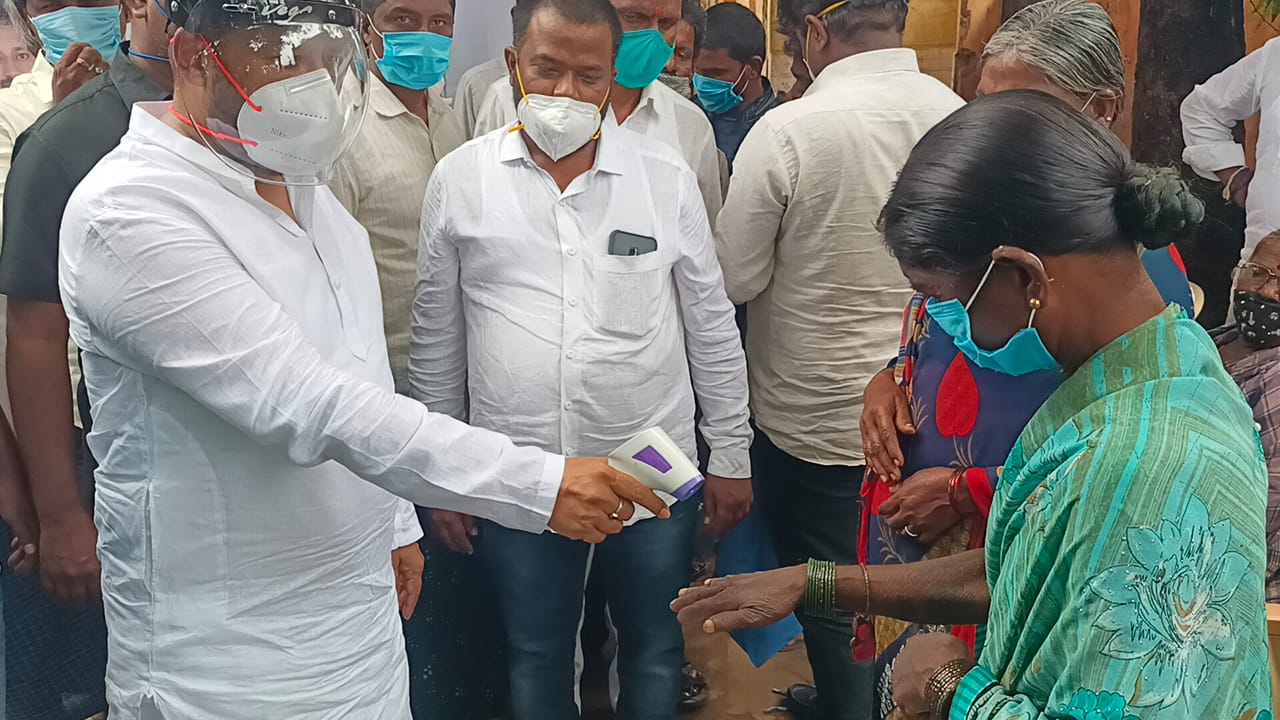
[59,102,563,720]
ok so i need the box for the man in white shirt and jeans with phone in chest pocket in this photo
[410,0,751,720]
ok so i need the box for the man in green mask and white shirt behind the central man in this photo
[472,0,724,222]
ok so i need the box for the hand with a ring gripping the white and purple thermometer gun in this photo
[547,457,671,543]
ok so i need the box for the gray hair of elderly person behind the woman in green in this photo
[982,0,1125,103]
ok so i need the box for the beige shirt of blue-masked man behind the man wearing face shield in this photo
[329,77,465,393]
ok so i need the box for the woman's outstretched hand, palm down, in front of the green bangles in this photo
[671,565,808,633]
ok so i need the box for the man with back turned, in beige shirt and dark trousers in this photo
[716,0,963,720]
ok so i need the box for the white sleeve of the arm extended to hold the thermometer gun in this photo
[60,190,563,532]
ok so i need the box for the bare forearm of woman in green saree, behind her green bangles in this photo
[836,550,991,625]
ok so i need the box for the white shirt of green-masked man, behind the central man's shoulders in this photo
[472,77,724,225]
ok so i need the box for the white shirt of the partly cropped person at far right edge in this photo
[1181,38,1280,260]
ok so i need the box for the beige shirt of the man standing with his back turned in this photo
[716,49,964,465]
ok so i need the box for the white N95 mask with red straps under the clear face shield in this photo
[236,69,346,178]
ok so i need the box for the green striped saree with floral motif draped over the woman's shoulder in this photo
[951,307,1271,720]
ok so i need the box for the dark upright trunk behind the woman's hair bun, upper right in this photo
[1133,0,1244,327]
